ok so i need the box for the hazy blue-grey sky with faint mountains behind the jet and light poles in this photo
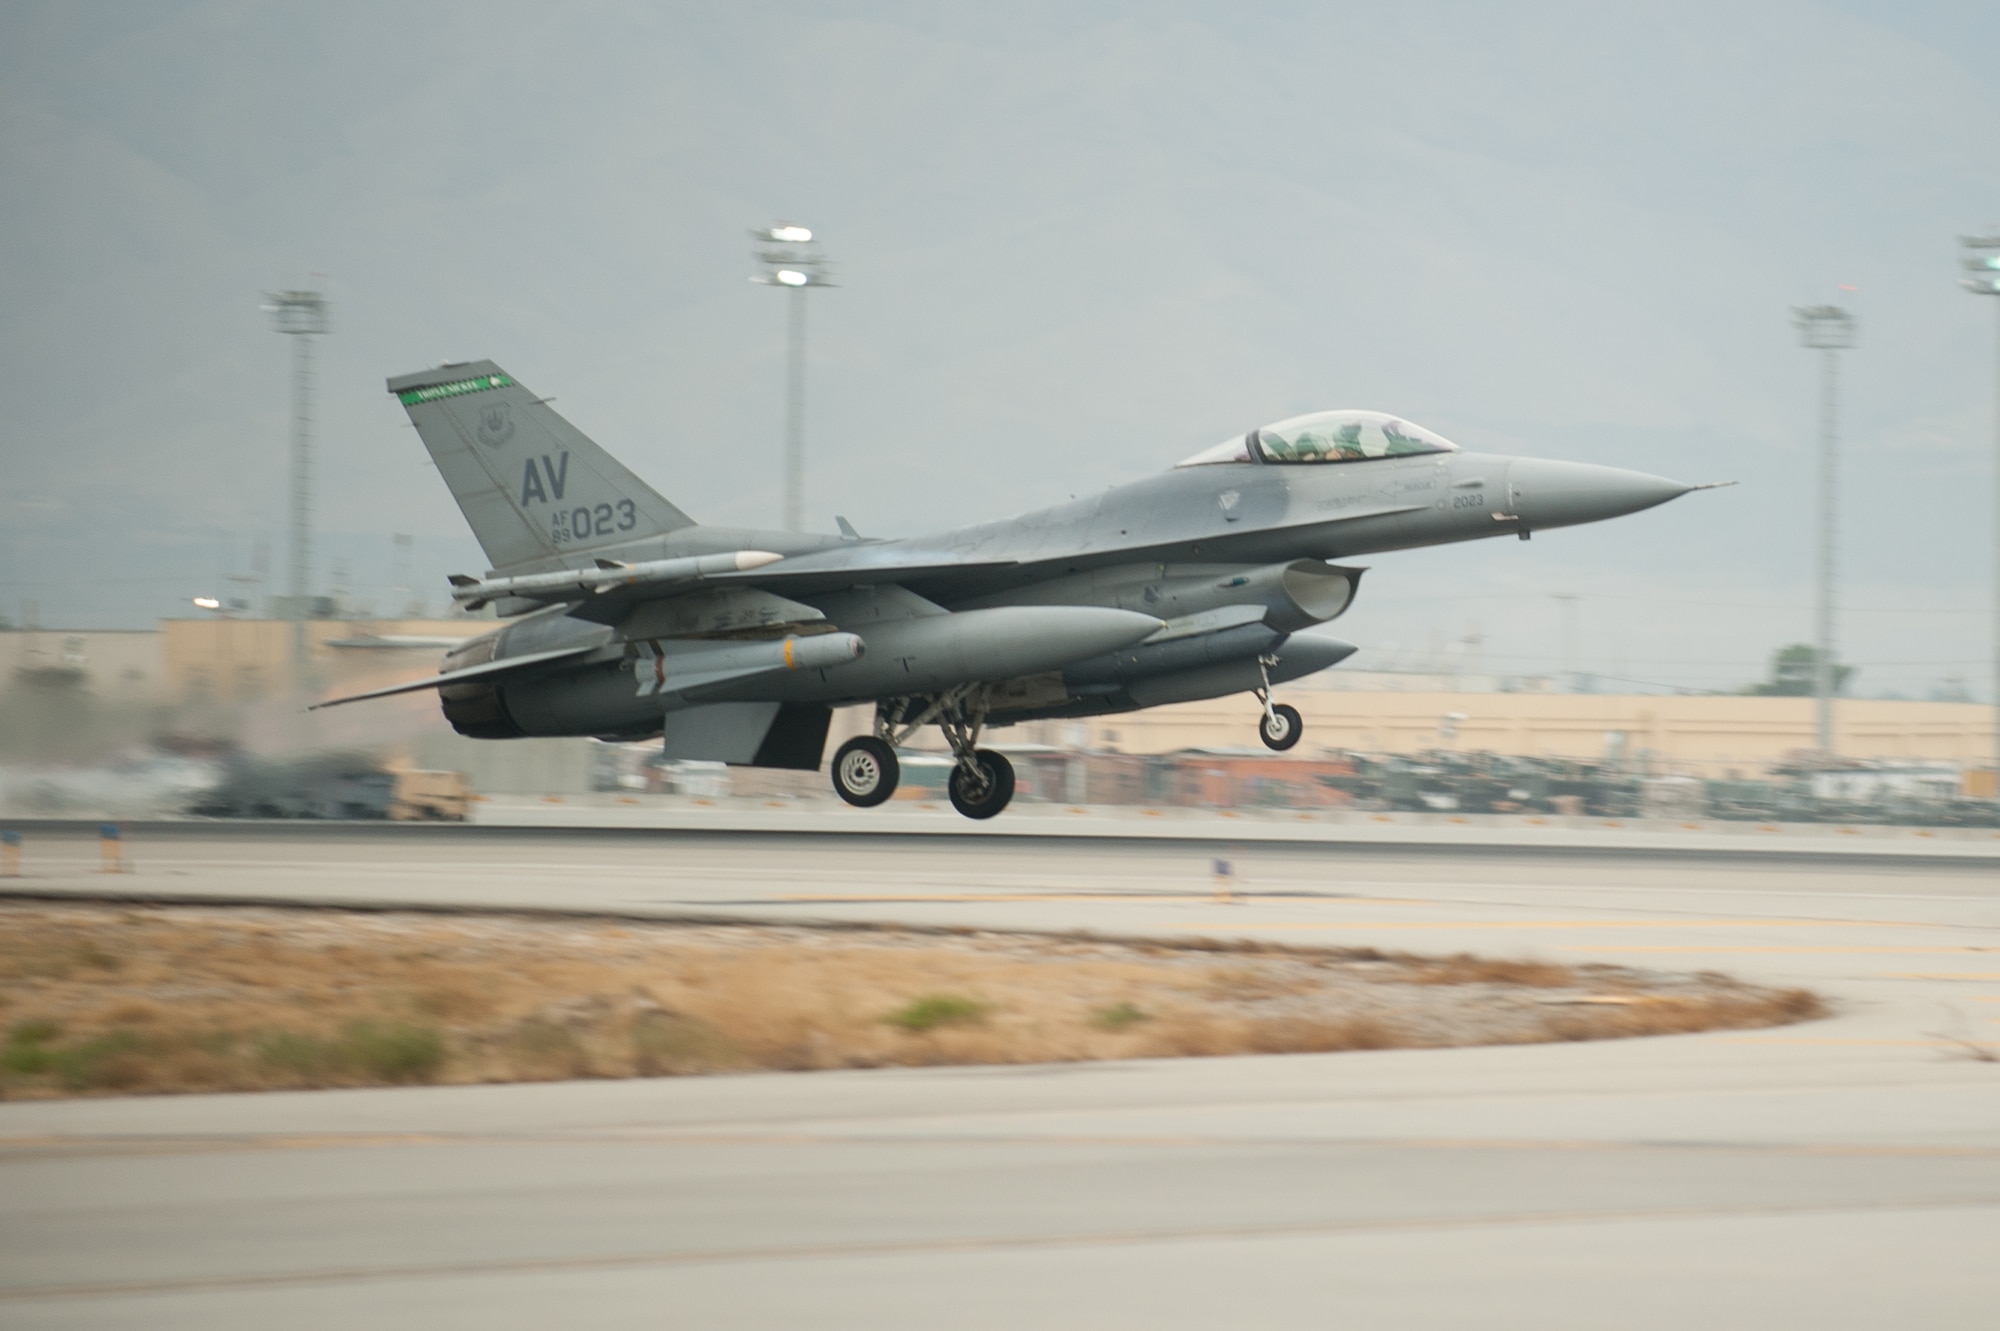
[0,0,2000,695]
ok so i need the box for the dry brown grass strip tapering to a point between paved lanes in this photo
[0,903,1822,1095]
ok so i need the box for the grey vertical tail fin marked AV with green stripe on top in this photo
[388,360,694,568]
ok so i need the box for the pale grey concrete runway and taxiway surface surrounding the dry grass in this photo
[0,829,2000,1327]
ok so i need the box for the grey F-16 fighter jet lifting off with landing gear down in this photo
[320,360,1698,817]
